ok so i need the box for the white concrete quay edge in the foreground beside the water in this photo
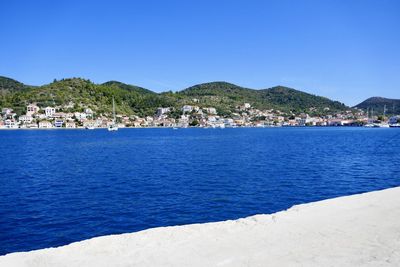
[0,187,400,267]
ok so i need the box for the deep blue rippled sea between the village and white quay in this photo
[0,127,400,255]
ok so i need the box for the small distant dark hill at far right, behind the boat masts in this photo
[355,97,400,115]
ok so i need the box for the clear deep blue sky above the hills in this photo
[0,0,400,105]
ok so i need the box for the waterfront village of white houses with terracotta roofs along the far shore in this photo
[0,99,400,129]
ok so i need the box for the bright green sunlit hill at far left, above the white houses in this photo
[0,78,172,116]
